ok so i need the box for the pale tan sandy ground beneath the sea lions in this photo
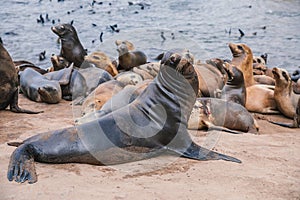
[0,95,300,200]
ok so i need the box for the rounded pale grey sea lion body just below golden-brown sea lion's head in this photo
[79,66,114,94]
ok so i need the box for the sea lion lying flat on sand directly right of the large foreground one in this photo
[188,98,259,134]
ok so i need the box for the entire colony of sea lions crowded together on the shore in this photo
[0,24,300,183]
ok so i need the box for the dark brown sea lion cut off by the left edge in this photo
[0,43,40,114]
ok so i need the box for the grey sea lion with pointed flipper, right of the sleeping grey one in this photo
[44,63,87,101]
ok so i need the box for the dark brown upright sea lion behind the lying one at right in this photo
[221,63,246,106]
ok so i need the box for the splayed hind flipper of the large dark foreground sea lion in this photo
[7,144,37,183]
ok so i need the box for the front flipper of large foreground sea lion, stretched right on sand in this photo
[172,142,242,163]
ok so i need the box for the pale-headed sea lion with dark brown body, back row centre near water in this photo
[117,43,147,70]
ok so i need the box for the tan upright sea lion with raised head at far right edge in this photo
[273,67,300,119]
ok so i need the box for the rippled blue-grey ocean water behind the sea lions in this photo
[0,0,300,72]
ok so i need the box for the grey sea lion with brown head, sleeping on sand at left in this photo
[20,68,62,103]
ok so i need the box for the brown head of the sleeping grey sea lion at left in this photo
[38,85,62,103]
